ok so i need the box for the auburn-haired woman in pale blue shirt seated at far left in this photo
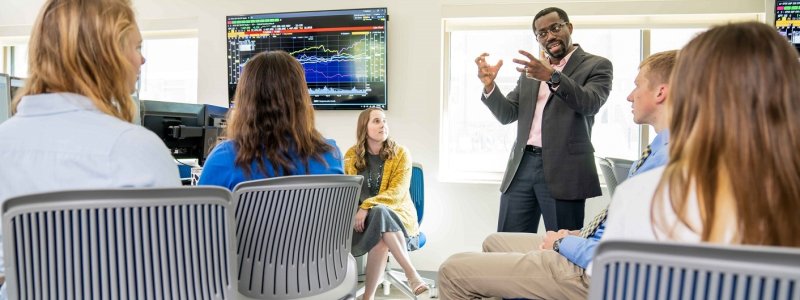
[0,0,181,294]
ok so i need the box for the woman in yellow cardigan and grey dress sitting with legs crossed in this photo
[344,108,428,300]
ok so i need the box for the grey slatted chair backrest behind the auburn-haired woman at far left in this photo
[3,187,233,299]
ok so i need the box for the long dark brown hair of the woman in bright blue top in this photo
[227,51,333,176]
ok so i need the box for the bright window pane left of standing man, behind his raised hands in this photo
[440,30,534,180]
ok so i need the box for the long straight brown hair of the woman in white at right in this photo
[652,22,800,246]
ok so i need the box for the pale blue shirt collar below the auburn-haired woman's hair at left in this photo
[17,93,99,117]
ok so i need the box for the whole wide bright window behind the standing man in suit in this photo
[440,14,758,182]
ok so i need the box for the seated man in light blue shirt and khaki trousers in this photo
[439,51,677,300]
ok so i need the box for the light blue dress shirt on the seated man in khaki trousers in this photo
[558,130,669,269]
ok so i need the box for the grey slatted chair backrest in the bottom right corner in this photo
[589,241,800,300]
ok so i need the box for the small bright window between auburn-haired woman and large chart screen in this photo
[139,38,198,103]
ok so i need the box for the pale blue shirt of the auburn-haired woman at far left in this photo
[0,93,181,282]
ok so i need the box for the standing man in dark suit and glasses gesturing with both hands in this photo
[475,7,612,233]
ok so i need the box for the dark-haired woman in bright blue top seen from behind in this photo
[198,51,344,190]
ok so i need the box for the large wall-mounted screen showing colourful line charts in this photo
[227,8,388,110]
